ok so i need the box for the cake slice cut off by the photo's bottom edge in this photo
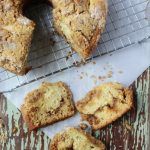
[50,128,105,150]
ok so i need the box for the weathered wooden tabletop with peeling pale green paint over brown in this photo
[0,67,150,150]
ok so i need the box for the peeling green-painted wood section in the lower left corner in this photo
[0,95,50,150]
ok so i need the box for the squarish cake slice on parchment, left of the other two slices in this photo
[21,82,75,130]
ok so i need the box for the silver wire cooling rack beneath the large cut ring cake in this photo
[0,0,150,91]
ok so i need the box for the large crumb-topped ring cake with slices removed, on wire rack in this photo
[0,0,107,75]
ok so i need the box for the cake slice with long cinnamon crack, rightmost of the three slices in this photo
[76,83,133,130]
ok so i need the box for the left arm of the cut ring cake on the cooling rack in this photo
[0,0,35,75]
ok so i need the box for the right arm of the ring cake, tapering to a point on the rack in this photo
[51,0,107,58]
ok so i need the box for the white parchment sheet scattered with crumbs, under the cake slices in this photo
[5,41,150,138]
